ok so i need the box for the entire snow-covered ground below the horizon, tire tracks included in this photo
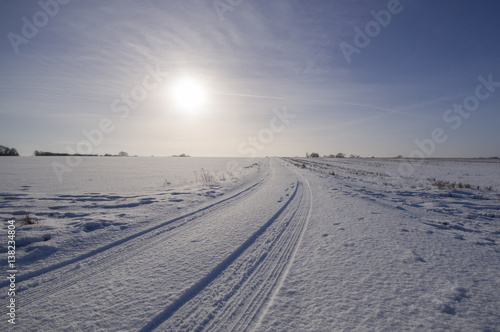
[0,157,500,331]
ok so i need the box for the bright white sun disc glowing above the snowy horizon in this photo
[171,78,207,110]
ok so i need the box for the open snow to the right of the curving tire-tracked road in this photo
[263,160,500,331]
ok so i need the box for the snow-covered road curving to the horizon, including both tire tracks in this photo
[1,160,312,331]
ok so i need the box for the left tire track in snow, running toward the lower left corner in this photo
[0,167,274,314]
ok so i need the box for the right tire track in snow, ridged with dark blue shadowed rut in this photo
[142,160,312,331]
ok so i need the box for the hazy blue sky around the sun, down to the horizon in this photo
[0,0,500,157]
